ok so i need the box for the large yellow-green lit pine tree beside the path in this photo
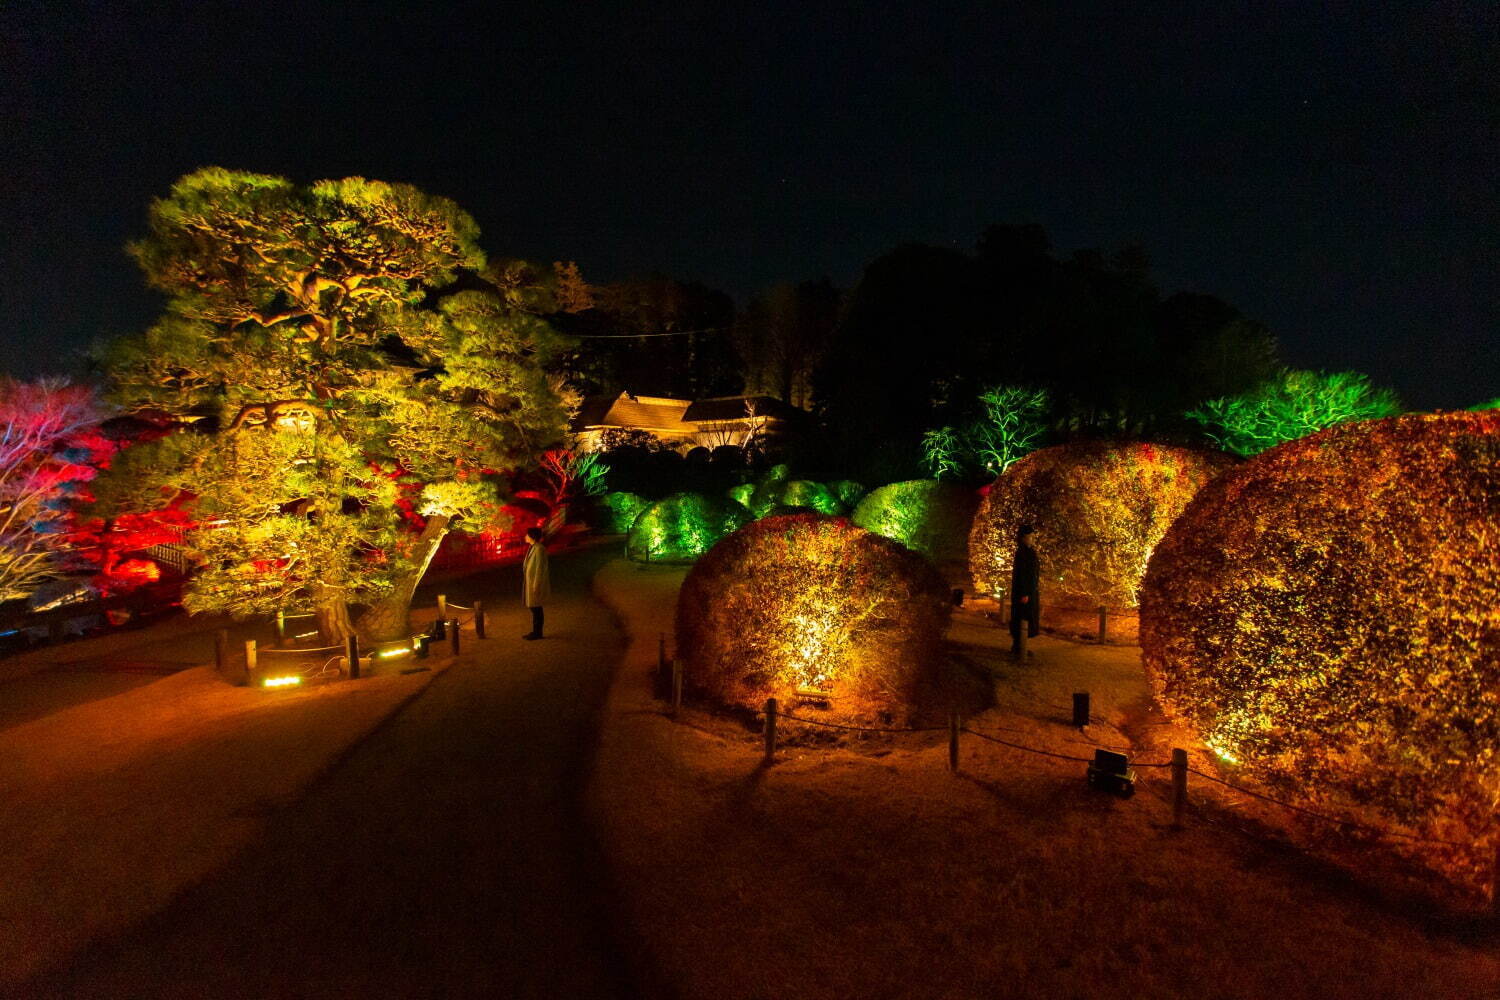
[96,168,566,642]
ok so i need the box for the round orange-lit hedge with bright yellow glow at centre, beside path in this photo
[677,514,953,715]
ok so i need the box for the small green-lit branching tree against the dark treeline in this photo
[923,385,1049,480]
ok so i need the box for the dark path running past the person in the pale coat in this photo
[24,549,645,997]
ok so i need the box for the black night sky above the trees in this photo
[0,0,1500,406]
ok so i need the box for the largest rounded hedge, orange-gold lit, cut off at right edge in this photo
[1140,412,1500,891]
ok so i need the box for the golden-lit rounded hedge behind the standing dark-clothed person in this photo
[969,441,1235,610]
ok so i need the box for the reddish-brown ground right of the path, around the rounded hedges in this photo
[591,561,1500,1000]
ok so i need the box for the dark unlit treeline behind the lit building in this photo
[558,225,1281,475]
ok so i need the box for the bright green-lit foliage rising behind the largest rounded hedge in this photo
[1187,370,1401,456]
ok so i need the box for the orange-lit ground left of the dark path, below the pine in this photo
[0,602,473,993]
